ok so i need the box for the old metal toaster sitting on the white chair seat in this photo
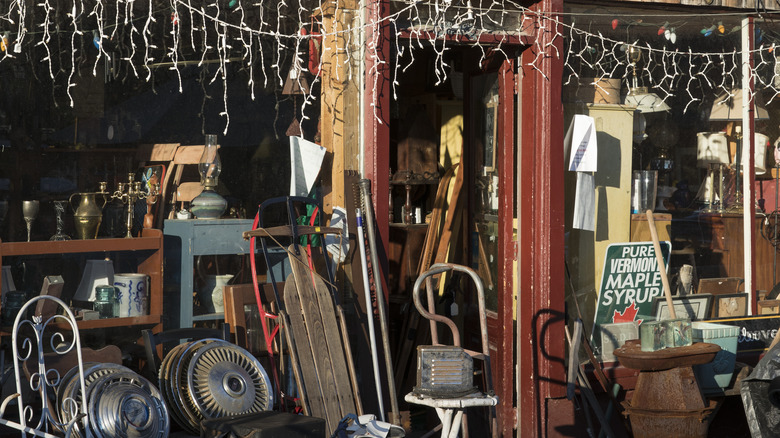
[413,345,476,398]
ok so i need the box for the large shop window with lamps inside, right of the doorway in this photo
[562,7,779,350]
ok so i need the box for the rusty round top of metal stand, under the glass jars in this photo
[614,339,720,371]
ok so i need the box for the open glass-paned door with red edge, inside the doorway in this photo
[464,60,516,436]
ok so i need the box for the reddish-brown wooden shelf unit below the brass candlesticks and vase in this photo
[0,229,163,334]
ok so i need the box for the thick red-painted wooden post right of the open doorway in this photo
[517,0,566,437]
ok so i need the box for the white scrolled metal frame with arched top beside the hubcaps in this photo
[0,295,93,438]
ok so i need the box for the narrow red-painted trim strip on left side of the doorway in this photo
[363,0,390,300]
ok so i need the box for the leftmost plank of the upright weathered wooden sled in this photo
[284,274,328,430]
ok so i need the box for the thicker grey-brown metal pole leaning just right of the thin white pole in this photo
[358,178,401,425]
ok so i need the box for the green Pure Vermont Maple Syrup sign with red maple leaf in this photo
[594,242,672,342]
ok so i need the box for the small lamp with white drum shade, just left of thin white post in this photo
[696,132,731,212]
